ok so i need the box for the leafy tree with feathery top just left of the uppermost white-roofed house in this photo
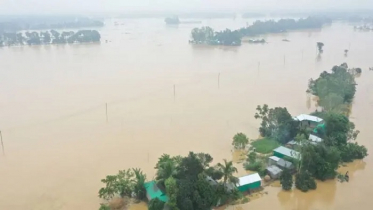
[254,104,298,144]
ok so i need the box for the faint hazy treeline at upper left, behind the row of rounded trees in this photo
[0,16,104,33]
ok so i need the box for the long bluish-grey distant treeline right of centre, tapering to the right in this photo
[190,17,331,46]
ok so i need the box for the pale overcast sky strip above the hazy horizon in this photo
[0,0,373,14]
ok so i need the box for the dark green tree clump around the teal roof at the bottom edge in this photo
[99,152,242,210]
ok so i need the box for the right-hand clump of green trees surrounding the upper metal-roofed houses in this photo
[240,63,368,192]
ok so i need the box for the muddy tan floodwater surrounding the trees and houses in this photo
[0,19,373,210]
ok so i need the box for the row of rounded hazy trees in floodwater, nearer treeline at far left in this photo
[0,30,101,47]
